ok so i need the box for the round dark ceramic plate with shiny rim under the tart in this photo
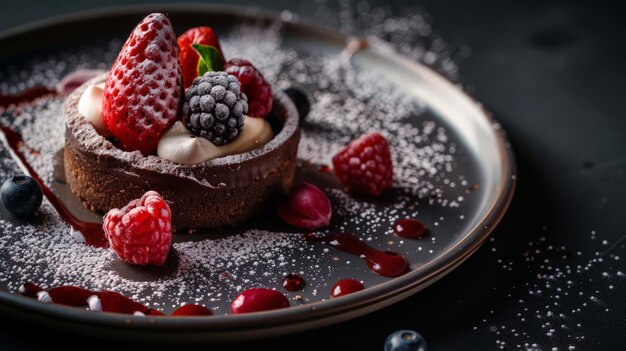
[0,6,515,341]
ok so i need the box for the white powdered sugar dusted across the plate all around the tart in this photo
[0,18,470,314]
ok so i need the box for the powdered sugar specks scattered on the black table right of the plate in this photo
[473,230,626,351]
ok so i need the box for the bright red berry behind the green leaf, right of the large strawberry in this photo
[178,27,226,89]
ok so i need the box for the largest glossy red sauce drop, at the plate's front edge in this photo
[230,288,289,314]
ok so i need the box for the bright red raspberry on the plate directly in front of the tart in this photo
[102,191,172,265]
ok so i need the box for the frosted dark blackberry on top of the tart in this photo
[183,71,248,145]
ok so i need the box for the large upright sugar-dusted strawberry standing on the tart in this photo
[102,13,183,155]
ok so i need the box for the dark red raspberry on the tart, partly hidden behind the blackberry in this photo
[225,59,273,118]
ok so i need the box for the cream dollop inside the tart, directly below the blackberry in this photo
[157,116,274,165]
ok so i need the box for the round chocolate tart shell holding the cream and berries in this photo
[64,76,300,228]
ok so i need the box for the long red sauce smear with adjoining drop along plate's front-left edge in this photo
[19,283,213,316]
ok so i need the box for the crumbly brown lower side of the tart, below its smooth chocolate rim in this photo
[65,142,296,228]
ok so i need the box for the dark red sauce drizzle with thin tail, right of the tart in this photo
[306,233,409,277]
